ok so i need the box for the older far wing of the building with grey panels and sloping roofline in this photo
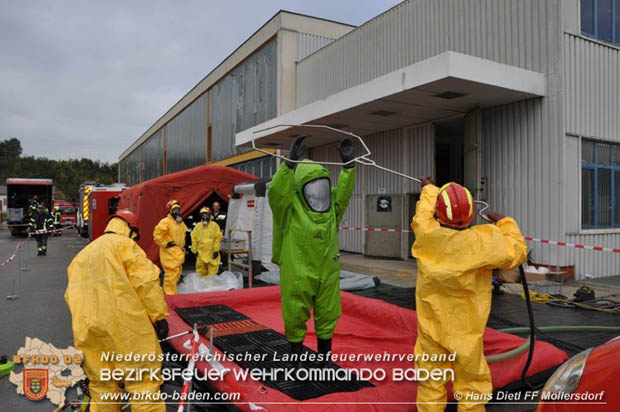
[119,11,354,181]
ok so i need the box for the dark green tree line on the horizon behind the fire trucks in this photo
[0,137,118,201]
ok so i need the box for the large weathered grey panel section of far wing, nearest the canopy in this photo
[209,40,278,161]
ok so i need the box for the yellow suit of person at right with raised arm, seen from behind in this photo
[411,185,527,411]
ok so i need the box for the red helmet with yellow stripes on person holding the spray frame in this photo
[435,182,474,229]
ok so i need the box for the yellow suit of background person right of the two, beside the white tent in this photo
[192,221,222,276]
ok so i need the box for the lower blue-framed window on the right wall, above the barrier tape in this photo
[581,140,620,229]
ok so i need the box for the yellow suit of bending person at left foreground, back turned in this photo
[65,218,168,412]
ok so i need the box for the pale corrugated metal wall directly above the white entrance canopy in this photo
[297,0,561,107]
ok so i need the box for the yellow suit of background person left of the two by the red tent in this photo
[153,214,187,295]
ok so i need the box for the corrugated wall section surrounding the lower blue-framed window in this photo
[560,34,620,278]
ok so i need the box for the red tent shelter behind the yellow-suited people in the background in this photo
[118,166,257,263]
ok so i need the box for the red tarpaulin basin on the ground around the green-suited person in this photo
[166,286,568,412]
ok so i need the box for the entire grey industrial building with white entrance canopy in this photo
[119,0,620,278]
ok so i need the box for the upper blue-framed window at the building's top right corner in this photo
[581,0,620,45]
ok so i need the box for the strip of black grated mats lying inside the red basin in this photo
[176,305,374,401]
